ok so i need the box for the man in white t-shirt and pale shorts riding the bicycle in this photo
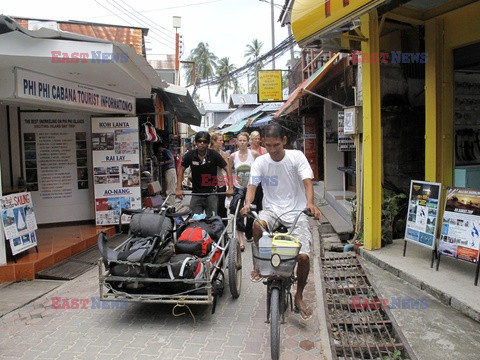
[241,123,321,320]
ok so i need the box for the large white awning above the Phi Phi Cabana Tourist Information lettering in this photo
[0,15,167,103]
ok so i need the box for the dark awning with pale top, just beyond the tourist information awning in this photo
[157,84,202,126]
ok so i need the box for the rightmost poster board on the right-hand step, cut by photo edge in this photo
[439,188,480,263]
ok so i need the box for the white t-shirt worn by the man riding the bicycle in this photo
[250,150,313,222]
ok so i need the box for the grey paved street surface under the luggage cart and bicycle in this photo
[0,218,329,360]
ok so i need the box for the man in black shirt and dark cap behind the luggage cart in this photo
[176,131,233,216]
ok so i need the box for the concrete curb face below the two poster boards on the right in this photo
[360,248,480,322]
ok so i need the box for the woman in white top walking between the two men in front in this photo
[228,132,259,251]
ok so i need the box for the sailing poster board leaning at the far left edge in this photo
[0,192,37,255]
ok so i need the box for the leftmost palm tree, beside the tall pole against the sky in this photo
[185,42,217,102]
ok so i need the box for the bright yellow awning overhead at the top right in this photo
[291,0,386,47]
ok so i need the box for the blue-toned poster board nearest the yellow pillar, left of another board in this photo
[405,180,442,249]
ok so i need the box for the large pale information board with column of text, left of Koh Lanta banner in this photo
[20,112,93,224]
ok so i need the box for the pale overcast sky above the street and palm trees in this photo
[1,0,296,101]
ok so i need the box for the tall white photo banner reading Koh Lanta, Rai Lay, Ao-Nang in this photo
[92,117,142,225]
